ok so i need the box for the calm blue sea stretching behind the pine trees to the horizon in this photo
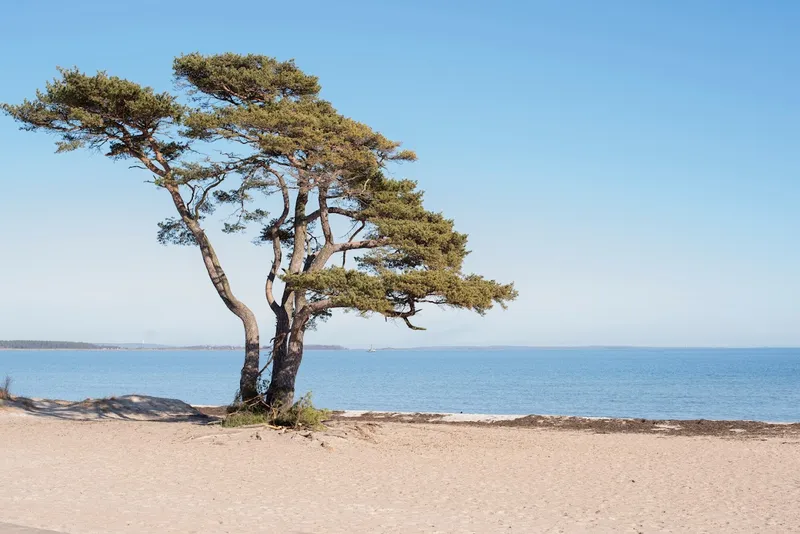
[0,349,800,421]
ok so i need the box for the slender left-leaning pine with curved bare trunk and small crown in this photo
[2,69,268,400]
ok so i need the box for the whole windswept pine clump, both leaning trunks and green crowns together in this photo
[3,54,516,408]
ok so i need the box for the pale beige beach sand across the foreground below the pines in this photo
[0,402,800,534]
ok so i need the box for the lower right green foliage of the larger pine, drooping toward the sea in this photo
[282,176,517,329]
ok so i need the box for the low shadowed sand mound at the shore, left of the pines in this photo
[7,395,208,421]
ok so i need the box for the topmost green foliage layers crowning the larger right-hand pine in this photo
[174,53,416,173]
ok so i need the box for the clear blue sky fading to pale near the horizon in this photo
[0,0,800,347]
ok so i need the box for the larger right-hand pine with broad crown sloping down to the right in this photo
[174,54,517,408]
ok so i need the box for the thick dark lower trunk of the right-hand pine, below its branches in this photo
[266,317,308,410]
